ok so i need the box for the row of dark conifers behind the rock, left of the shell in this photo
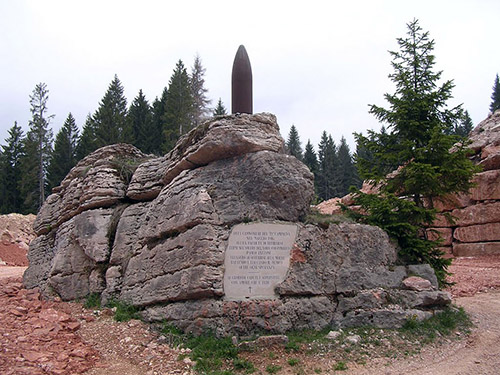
[0,56,226,213]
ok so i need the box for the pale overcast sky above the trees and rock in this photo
[0,0,500,148]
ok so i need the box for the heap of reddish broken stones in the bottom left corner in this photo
[0,274,99,375]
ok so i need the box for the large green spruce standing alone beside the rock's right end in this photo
[355,20,477,281]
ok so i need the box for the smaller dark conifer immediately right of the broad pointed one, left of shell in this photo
[128,90,154,153]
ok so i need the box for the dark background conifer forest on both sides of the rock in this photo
[0,46,500,217]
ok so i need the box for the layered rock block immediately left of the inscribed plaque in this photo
[120,225,227,305]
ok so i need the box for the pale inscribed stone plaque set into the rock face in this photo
[224,223,297,301]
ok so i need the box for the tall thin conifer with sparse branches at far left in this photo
[20,83,54,213]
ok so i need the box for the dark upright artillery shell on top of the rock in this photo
[231,45,253,114]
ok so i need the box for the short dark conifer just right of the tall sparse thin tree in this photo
[48,112,78,187]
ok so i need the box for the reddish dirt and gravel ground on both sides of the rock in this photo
[0,256,500,375]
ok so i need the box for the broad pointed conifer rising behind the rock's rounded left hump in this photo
[93,74,130,147]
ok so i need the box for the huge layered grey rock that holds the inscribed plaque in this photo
[24,114,450,335]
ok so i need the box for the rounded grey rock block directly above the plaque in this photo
[140,151,313,245]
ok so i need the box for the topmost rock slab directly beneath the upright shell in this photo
[163,113,284,185]
